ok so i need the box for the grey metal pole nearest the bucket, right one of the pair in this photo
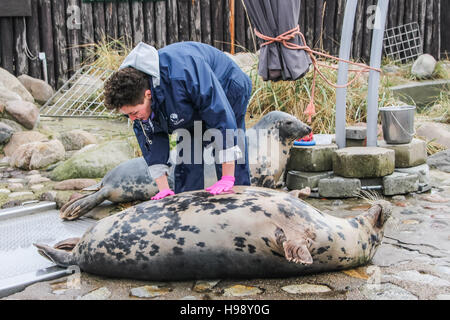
[367,0,389,147]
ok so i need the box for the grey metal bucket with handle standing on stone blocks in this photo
[380,106,416,144]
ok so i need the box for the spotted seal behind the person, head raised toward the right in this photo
[60,111,311,220]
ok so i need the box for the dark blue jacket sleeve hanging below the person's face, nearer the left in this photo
[133,124,170,179]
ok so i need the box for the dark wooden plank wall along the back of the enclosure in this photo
[0,0,442,87]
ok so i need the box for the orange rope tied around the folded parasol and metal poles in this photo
[255,25,381,123]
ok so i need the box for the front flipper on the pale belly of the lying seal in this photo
[275,228,313,264]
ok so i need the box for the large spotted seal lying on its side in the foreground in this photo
[35,186,391,281]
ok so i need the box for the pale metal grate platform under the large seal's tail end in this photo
[0,205,96,297]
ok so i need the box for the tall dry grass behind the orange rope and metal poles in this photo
[248,58,397,133]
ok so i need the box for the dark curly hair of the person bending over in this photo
[104,67,149,110]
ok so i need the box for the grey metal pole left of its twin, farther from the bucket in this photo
[336,0,358,149]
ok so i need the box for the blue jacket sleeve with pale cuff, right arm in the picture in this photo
[172,57,242,163]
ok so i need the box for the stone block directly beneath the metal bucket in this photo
[378,139,427,168]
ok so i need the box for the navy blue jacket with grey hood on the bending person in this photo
[121,42,251,178]
